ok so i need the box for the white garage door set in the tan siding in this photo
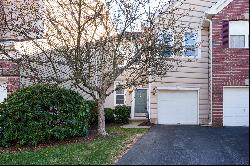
[158,90,198,125]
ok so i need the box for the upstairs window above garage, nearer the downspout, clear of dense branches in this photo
[184,32,198,57]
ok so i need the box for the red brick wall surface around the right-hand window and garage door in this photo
[212,0,249,126]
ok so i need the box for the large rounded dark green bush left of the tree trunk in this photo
[0,84,90,146]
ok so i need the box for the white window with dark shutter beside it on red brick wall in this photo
[229,21,249,48]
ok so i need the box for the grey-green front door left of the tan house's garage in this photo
[135,89,147,117]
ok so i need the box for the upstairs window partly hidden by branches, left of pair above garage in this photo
[158,31,174,57]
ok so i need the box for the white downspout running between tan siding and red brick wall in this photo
[205,19,213,126]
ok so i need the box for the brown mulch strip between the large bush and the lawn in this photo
[0,129,100,153]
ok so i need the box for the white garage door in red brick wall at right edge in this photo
[223,88,249,126]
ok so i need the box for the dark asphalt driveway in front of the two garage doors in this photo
[117,125,249,165]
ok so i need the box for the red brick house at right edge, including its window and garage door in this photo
[206,0,249,126]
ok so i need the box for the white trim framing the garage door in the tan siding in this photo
[157,86,200,125]
